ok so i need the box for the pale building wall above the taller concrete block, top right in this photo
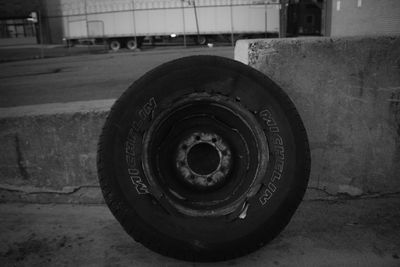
[328,0,400,36]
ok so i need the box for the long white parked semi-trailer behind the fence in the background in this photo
[61,0,280,50]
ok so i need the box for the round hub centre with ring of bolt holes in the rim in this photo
[176,132,232,189]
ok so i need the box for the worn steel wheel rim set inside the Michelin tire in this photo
[142,94,269,217]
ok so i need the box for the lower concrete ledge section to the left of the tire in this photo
[0,99,114,203]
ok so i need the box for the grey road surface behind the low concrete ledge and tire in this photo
[0,47,233,107]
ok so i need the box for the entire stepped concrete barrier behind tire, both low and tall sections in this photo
[0,37,400,203]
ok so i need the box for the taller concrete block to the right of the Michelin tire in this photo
[235,36,400,196]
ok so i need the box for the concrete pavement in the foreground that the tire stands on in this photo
[0,195,400,266]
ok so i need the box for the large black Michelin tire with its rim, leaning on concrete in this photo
[97,56,310,261]
